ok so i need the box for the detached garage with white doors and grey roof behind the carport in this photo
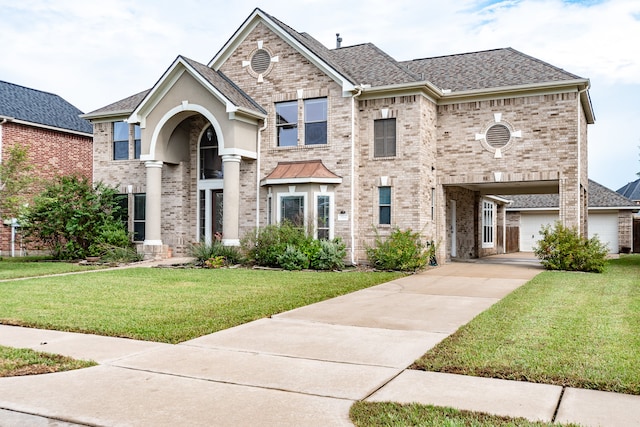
[505,180,640,253]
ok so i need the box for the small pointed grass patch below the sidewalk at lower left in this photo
[0,346,96,377]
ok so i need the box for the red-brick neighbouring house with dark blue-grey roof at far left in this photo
[0,81,93,254]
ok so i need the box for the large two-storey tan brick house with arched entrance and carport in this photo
[83,9,594,262]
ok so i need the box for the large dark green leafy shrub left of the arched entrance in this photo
[21,176,131,259]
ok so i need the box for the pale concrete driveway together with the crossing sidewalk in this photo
[0,256,640,426]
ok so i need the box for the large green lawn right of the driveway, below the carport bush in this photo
[414,255,640,395]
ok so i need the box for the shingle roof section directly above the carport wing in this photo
[400,47,581,92]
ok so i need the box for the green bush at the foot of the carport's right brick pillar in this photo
[533,222,609,273]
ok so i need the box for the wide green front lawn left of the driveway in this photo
[0,268,399,343]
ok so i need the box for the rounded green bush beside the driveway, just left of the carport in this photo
[367,228,430,271]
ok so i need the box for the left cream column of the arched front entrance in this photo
[144,160,162,254]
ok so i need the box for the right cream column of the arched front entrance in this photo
[222,154,241,246]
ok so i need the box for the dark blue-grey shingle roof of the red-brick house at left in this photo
[0,81,93,134]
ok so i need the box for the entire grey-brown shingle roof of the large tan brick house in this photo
[90,9,586,115]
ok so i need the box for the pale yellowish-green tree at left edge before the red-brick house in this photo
[0,144,35,220]
